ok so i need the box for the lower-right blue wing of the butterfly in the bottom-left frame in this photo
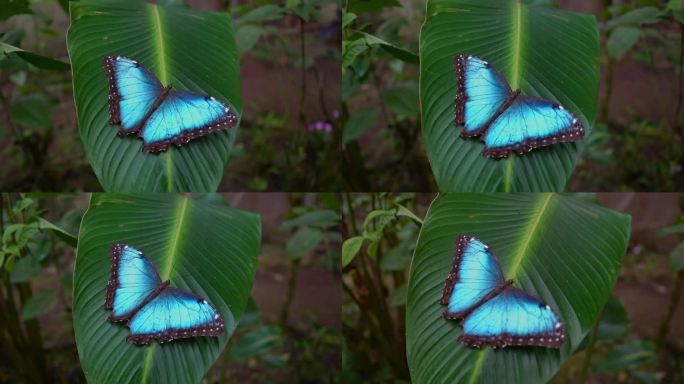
[126,288,224,344]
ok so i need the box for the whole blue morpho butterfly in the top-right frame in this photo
[454,55,584,158]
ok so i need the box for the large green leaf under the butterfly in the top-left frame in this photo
[67,1,242,192]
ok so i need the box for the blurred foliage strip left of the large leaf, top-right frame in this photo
[342,0,435,191]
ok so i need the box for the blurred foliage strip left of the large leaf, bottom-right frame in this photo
[342,193,426,383]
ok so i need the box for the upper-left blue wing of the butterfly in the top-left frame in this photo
[102,56,164,135]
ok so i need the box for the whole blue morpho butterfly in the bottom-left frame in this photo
[105,244,224,344]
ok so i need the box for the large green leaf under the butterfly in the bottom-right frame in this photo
[406,193,630,384]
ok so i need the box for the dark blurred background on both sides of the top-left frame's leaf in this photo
[0,0,340,192]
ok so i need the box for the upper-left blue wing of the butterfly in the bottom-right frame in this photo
[440,235,505,319]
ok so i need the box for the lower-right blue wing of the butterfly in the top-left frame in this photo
[139,91,237,152]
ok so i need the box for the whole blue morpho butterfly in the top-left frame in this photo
[103,56,238,152]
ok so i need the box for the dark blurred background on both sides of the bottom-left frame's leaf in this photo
[0,193,342,383]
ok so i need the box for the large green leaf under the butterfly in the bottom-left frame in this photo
[73,194,261,383]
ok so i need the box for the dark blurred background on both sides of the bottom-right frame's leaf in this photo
[342,193,684,384]
